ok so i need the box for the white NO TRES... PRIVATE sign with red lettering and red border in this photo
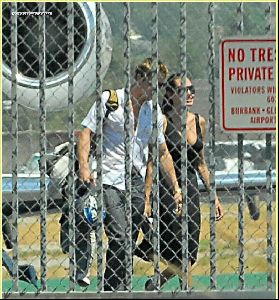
[220,37,276,132]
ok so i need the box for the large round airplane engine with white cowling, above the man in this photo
[2,2,112,111]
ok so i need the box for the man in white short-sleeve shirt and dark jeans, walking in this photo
[78,59,182,291]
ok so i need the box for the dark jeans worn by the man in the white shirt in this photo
[104,170,144,291]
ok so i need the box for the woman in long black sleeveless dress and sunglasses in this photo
[137,74,223,290]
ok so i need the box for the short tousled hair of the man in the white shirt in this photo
[135,57,169,81]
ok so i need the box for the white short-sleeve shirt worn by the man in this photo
[82,89,165,190]
